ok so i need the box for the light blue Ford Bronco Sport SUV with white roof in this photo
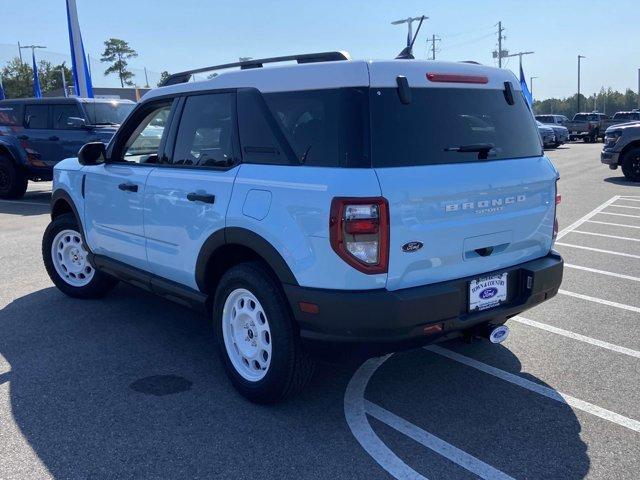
[43,52,563,402]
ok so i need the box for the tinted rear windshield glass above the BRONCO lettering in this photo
[370,88,542,167]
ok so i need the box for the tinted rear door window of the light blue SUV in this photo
[171,93,236,167]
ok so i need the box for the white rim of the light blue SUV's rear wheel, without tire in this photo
[222,288,272,382]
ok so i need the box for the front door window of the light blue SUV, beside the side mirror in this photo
[122,103,171,163]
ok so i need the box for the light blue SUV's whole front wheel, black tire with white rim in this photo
[42,213,118,298]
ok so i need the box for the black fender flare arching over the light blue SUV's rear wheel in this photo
[195,227,298,291]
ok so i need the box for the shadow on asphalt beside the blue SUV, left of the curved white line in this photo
[0,285,371,478]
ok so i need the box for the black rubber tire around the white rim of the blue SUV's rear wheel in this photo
[213,262,315,404]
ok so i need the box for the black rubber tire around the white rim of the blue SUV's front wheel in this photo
[42,213,118,298]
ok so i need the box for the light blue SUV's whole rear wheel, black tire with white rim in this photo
[213,262,314,403]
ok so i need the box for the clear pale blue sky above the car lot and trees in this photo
[0,0,640,99]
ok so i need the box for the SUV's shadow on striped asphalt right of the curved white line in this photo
[367,341,590,479]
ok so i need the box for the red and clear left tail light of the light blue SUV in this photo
[329,197,389,274]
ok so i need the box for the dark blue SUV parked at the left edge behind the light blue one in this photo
[0,98,135,199]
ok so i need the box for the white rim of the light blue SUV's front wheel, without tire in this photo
[51,229,95,287]
